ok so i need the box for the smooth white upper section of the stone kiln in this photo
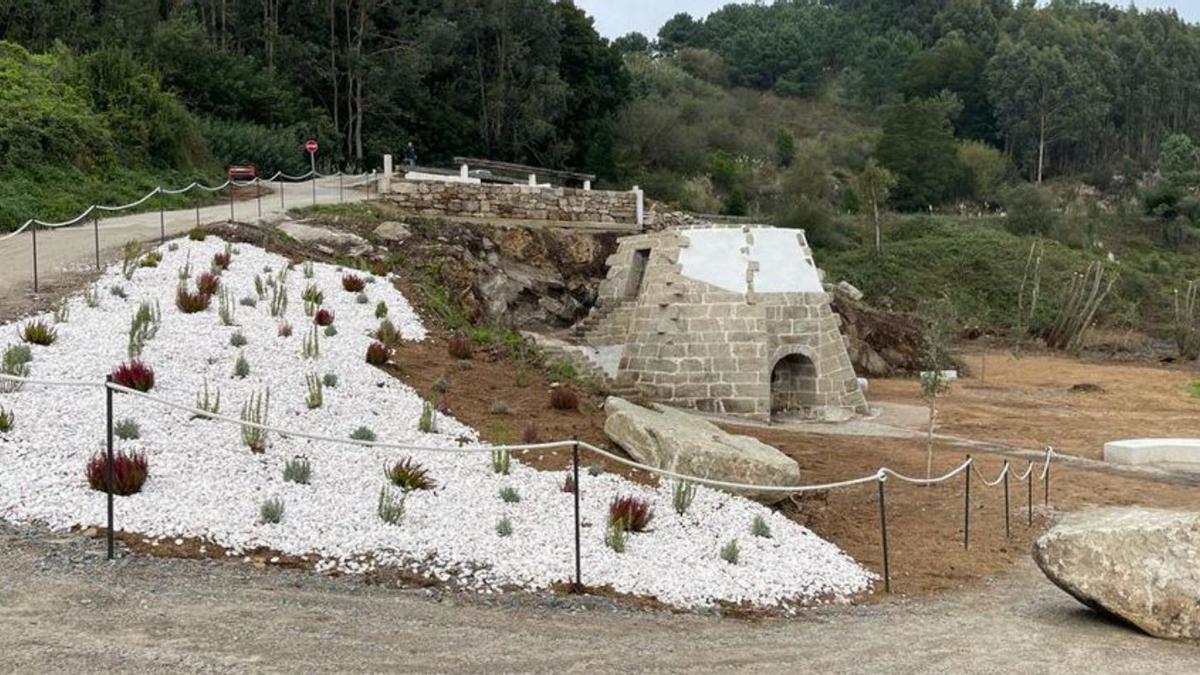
[679,227,823,293]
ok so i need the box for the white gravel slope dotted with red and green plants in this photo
[0,237,875,607]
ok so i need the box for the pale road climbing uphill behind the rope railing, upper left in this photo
[0,177,366,298]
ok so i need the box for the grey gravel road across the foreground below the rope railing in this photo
[0,525,1200,675]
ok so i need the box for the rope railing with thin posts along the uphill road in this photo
[0,169,376,293]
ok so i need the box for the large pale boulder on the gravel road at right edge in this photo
[1033,508,1200,639]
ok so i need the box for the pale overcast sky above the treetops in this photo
[575,0,1200,37]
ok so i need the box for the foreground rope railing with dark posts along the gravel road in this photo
[0,374,1057,592]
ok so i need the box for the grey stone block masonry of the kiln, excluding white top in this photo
[587,223,868,419]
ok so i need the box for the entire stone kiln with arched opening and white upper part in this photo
[577,225,868,420]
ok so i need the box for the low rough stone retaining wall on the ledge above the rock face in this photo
[386,180,653,225]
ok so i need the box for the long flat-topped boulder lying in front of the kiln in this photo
[604,396,800,503]
